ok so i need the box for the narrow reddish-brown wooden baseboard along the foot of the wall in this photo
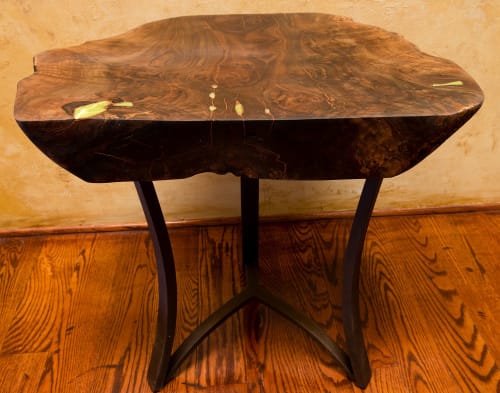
[0,202,500,238]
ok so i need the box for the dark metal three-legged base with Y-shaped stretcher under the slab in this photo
[135,177,382,392]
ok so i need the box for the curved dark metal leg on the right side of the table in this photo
[342,178,382,388]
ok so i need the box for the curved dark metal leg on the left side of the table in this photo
[135,182,177,392]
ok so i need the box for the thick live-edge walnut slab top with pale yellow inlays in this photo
[15,14,483,181]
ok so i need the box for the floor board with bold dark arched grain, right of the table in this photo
[376,217,500,392]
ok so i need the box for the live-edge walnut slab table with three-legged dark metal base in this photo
[15,14,483,391]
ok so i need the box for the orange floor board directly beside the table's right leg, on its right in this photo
[362,223,460,392]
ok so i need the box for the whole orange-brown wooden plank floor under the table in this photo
[0,212,500,393]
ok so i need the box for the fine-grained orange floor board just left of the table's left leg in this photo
[32,234,155,392]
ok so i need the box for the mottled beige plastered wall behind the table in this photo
[0,0,500,228]
